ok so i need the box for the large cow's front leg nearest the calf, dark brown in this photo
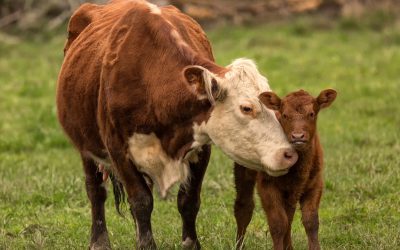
[178,145,211,249]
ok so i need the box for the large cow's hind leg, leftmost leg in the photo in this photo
[82,156,111,250]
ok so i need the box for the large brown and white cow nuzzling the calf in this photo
[57,0,297,249]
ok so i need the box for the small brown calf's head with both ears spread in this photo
[260,89,336,151]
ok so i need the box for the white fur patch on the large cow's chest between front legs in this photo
[129,133,189,198]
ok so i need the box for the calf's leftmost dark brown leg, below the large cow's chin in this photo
[234,163,257,249]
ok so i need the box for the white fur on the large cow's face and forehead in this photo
[202,59,291,174]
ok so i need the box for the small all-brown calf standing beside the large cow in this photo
[234,89,337,250]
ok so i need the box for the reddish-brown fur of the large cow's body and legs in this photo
[57,0,230,249]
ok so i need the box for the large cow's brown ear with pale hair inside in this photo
[183,65,226,104]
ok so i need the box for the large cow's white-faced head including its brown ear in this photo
[184,59,297,176]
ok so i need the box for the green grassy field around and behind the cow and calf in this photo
[0,15,400,249]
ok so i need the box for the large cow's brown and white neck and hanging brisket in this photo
[129,97,211,197]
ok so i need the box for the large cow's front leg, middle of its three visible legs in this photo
[108,137,157,250]
